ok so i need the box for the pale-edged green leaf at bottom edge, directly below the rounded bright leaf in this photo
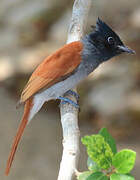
[110,173,135,180]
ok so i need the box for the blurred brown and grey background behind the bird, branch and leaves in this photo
[0,0,140,180]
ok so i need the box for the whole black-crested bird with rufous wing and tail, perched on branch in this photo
[5,18,135,175]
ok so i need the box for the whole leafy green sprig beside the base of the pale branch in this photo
[77,128,136,180]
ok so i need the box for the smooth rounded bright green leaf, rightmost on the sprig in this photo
[112,149,136,174]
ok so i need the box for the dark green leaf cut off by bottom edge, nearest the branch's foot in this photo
[86,172,108,180]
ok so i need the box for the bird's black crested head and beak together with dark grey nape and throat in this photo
[82,18,134,63]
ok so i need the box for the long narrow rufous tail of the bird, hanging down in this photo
[5,98,33,175]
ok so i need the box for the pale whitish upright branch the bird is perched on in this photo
[58,0,92,180]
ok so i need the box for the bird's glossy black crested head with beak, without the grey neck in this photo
[89,18,135,61]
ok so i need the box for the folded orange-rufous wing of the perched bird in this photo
[20,41,83,103]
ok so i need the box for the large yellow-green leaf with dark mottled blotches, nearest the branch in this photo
[82,134,113,169]
